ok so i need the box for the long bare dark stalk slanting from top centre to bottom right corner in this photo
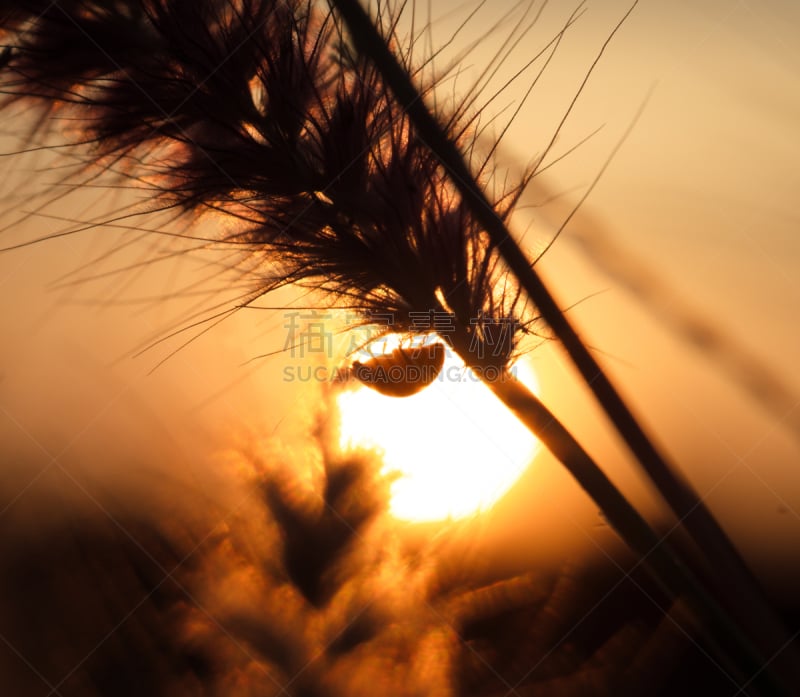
[333,0,800,686]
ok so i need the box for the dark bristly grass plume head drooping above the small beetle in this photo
[1,0,535,370]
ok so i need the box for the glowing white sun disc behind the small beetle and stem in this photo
[338,350,538,522]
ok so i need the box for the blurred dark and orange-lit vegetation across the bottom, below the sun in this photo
[0,416,728,697]
